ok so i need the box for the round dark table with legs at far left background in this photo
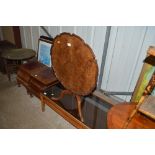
[1,48,36,81]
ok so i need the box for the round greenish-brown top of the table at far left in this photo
[1,48,36,60]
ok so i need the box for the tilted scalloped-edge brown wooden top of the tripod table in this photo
[51,33,98,95]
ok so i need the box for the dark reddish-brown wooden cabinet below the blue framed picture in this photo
[17,61,58,98]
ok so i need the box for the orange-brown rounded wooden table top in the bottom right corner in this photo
[107,103,155,129]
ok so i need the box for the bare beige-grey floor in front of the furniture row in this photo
[0,73,74,129]
